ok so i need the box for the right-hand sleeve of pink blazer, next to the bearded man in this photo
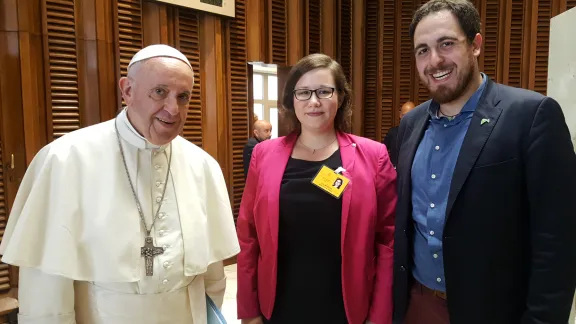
[368,145,397,324]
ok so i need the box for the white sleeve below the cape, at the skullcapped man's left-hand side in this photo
[18,267,76,324]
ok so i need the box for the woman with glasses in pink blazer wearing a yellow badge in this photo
[237,54,396,324]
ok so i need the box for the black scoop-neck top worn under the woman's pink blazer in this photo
[266,150,348,324]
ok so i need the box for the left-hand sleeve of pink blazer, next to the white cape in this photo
[236,145,261,319]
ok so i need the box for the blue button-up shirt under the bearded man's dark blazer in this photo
[412,74,486,292]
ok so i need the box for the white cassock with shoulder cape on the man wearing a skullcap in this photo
[0,108,240,324]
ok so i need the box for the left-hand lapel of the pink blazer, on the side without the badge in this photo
[265,134,297,252]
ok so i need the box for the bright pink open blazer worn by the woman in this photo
[237,133,396,324]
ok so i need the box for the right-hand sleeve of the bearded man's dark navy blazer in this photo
[522,98,576,324]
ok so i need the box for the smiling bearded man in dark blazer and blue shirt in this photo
[394,0,576,324]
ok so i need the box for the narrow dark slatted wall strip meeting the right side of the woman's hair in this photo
[338,0,352,83]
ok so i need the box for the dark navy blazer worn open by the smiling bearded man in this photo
[394,76,576,324]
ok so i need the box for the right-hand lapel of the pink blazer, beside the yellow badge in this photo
[338,132,356,249]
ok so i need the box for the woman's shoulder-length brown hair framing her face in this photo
[280,54,352,132]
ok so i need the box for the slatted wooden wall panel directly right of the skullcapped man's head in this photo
[176,8,202,147]
